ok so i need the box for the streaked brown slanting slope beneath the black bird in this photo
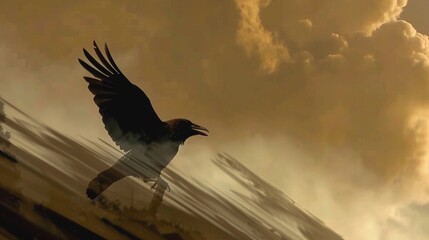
[0,100,342,240]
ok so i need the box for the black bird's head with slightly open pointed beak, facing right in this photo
[168,119,209,142]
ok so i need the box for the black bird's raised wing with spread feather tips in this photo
[79,41,164,151]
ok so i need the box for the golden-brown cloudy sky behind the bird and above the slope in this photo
[0,0,429,240]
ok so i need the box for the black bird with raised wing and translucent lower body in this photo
[79,41,208,199]
